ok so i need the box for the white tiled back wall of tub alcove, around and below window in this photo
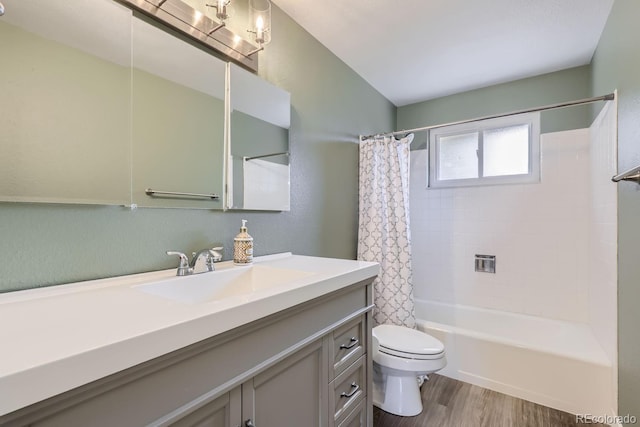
[411,129,591,323]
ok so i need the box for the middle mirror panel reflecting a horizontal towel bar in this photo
[132,16,225,209]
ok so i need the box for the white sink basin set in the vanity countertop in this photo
[134,265,315,304]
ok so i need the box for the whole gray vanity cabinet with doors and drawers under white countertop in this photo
[0,279,373,427]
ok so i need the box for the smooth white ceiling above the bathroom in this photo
[273,0,613,106]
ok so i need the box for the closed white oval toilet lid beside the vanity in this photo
[372,325,444,355]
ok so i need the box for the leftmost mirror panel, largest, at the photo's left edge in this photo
[0,0,132,205]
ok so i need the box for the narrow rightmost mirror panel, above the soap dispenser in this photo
[226,64,291,211]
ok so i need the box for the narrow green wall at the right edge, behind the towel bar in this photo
[593,0,640,417]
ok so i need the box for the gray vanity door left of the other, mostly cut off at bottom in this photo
[171,387,241,427]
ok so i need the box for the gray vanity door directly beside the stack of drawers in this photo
[242,340,328,427]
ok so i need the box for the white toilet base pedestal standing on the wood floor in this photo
[373,362,422,417]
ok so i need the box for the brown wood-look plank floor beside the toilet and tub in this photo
[373,374,604,427]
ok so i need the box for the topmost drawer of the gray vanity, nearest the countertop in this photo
[330,316,367,379]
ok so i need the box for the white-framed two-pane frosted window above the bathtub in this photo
[429,113,540,187]
